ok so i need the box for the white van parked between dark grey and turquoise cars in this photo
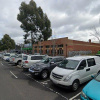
[50,56,100,91]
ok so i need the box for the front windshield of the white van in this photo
[58,59,79,70]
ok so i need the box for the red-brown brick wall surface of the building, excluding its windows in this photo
[33,37,100,56]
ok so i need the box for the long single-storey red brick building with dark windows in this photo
[33,37,100,57]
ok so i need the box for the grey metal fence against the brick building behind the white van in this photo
[68,51,92,57]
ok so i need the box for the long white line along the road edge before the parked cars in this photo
[23,73,69,100]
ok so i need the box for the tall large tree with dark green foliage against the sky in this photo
[17,0,52,44]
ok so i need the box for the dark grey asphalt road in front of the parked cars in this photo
[0,61,89,100]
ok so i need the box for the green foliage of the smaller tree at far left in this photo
[0,34,15,50]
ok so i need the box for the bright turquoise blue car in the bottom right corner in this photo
[80,74,100,100]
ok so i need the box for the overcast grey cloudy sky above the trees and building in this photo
[0,0,100,43]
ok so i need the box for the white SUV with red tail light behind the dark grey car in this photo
[22,55,45,69]
